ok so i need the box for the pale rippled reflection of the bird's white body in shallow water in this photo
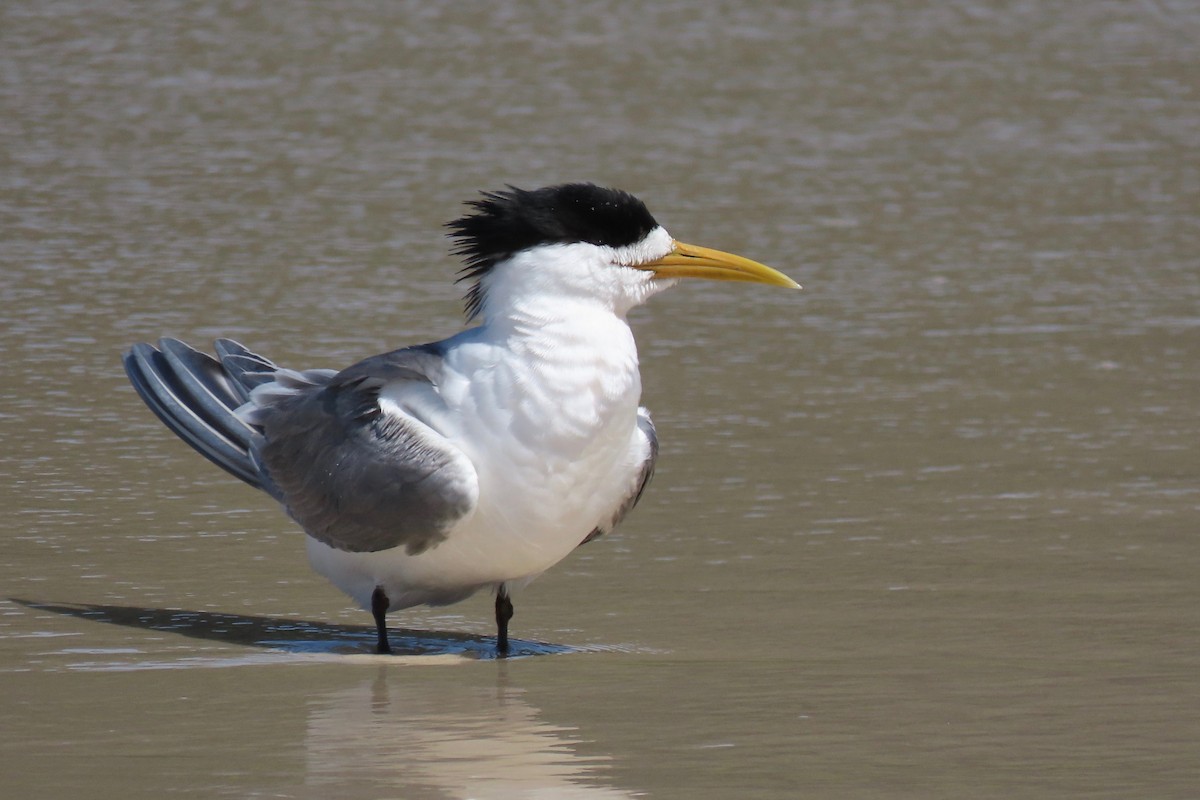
[306,667,636,799]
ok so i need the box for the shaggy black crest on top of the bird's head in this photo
[446,184,658,318]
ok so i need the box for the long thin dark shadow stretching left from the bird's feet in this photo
[8,597,577,660]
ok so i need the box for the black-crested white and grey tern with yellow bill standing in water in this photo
[124,182,800,657]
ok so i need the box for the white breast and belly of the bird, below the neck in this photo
[308,309,647,609]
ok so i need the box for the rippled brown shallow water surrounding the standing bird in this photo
[0,0,1200,799]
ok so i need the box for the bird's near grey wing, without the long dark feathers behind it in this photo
[247,345,479,554]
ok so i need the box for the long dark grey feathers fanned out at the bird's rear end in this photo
[125,338,278,493]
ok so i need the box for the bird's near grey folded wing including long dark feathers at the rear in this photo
[125,339,479,554]
